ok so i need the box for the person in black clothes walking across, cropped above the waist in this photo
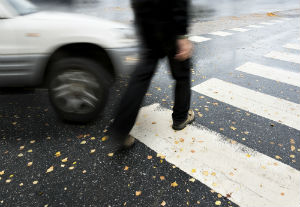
[110,0,194,148]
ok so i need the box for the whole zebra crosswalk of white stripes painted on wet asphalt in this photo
[131,31,300,207]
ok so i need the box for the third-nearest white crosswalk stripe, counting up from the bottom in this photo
[236,62,300,87]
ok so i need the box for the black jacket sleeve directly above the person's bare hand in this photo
[172,0,190,35]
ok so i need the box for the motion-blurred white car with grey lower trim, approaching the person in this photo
[0,0,138,122]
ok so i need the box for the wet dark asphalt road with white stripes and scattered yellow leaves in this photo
[0,1,300,207]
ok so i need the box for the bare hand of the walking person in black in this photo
[175,38,193,61]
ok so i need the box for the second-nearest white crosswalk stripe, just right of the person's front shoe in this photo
[192,78,300,130]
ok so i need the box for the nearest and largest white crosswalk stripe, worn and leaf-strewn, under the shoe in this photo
[131,104,300,207]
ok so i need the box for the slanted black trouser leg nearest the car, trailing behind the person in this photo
[110,53,158,141]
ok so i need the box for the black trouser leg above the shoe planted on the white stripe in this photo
[168,55,191,123]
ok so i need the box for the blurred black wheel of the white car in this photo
[48,58,112,123]
